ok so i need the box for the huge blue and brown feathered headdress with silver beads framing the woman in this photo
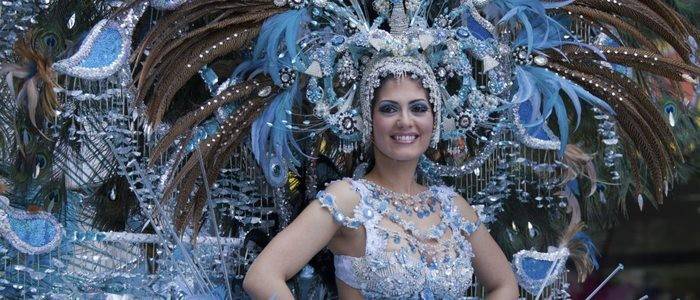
[46,0,700,291]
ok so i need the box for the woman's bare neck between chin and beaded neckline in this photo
[365,151,422,195]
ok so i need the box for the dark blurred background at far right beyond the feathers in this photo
[569,0,700,299]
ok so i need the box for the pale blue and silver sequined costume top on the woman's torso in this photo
[318,179,479,299]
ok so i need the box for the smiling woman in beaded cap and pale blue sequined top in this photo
[244,57,518,299]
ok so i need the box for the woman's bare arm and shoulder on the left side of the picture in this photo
[243,182,353,300]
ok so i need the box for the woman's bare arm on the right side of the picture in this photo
[455,196,519,300]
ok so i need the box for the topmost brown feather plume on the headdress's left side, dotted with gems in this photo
[136,2,282,124]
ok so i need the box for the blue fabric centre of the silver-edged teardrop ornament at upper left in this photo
[78,27,124,68]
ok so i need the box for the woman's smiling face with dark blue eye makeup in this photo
[372,77,433,161]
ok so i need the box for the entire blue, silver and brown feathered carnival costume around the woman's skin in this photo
[0,0,700,298]
